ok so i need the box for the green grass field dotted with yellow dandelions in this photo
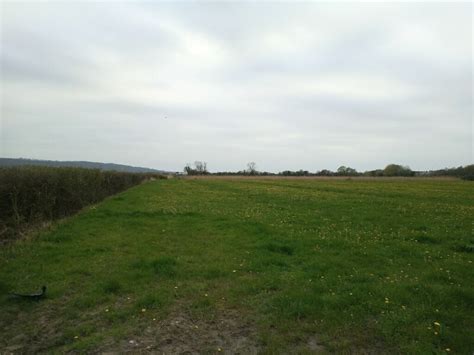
[0,179,474,354]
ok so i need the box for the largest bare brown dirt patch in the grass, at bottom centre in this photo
[102,311,261,354]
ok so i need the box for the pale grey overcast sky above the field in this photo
[0,1,473,171]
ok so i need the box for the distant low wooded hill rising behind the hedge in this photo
[0,158,170,174]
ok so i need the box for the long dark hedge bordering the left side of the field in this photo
[0,166,165,243]
